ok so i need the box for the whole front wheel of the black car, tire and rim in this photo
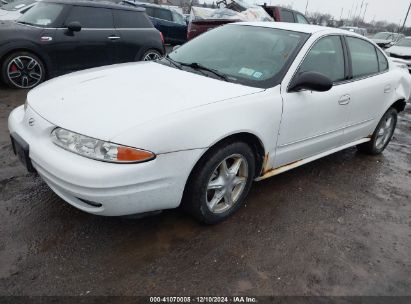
[1,52,46,89]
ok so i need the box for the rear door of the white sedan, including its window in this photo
[344,36,395,143]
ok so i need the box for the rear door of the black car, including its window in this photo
[113,10,155,63]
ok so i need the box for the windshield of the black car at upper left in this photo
[17,2,64,27]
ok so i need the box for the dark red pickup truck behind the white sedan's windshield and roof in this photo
[187,2,309,40]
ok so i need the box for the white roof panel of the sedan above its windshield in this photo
[235,22,347,34]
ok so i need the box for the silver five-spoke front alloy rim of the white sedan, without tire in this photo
[206,154,248,214]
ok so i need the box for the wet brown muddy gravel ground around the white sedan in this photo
[0,84,411,295]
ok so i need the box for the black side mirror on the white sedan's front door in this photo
[288,72,333,92]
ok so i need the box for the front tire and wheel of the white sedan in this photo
[182,142,255,224]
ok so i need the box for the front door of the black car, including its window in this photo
[54,6,119,72]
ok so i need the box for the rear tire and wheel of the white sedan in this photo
[357,108,398,155]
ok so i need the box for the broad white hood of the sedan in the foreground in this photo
[27,62,264,140]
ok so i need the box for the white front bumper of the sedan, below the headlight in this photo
[9,106,203,216]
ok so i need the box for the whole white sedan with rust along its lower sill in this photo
[9,22,411,223]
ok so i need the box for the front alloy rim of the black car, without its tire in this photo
[7,56,43,89]
